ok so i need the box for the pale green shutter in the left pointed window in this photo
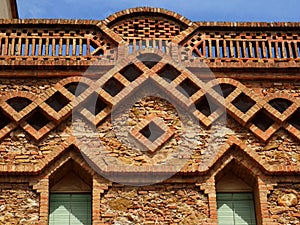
[49,194,92,225]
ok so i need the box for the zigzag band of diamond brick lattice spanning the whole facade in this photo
[0,51,300,144]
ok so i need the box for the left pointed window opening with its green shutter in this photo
[49,160,92,225]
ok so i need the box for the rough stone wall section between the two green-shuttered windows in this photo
[100,184,209,225]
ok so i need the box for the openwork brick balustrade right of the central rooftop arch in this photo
[184,30,300,62]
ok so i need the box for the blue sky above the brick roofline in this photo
[17,0,300,22]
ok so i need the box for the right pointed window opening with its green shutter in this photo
[216,161,257,225]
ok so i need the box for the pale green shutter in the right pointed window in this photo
[217,193,256,225]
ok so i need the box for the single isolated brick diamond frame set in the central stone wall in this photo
[131,115,174,153]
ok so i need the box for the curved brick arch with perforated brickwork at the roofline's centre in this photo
[103,7,193,42]
